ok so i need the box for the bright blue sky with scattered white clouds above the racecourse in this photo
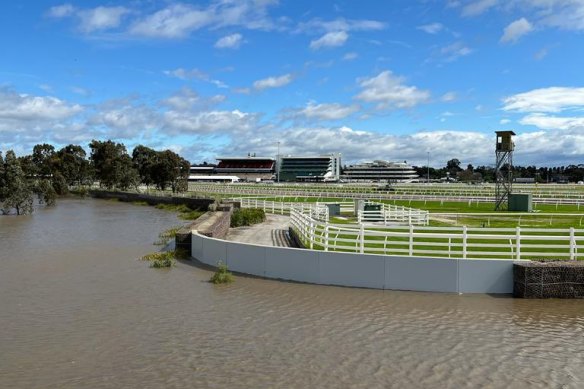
[0,0,584,167]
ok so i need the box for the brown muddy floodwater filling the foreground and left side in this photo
[0,200,584,388]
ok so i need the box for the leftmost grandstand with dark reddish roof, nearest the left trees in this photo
[214,156,276,181]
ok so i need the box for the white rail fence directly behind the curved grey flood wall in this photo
[290,209,584,260]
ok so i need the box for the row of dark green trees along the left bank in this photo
[0,140,190,215]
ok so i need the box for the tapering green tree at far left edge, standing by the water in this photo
[1,150,33,215]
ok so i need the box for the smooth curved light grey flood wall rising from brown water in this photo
[192,232,513,293]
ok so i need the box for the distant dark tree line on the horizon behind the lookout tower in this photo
[414,158,584,183]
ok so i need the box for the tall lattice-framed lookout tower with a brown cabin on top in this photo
[495,131,515,211]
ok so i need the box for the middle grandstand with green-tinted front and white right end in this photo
[280,154,341,182]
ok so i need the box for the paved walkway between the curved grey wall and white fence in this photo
[225,215,295,247]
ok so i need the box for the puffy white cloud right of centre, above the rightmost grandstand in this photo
[355,70,430,109]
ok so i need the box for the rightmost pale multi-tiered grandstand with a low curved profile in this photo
[341,160,419,182]
